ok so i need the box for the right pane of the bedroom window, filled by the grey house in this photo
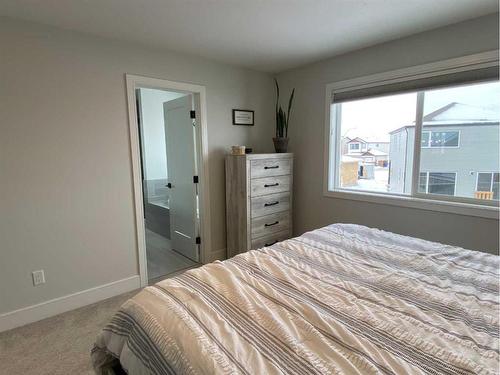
[420,82,500,199]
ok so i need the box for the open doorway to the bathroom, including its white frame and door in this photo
[127,75,208,285]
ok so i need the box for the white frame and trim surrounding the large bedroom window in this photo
[323,50,499,220]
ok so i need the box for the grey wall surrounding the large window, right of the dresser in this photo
[278,14,499,253]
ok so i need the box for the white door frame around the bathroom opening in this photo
[125,74,212,286]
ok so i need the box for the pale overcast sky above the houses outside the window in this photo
[336,82,500,142]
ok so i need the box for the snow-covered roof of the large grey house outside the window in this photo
[390,102,500,134]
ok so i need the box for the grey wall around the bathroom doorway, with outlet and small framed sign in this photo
[0,18,274,313]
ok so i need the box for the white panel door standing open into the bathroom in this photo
[163,94,199,262]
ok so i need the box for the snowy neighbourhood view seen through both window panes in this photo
[339,82,500,200]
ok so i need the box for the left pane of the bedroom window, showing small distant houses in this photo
[330,93,417,194]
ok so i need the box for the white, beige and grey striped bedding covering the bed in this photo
[92,224,500,375]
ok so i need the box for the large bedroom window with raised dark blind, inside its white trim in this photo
[326,55,500,214]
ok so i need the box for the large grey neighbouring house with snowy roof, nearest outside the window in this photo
[389,102,500,199]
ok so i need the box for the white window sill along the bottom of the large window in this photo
[323,190,500,220]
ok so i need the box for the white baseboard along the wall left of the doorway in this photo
[0,275,141,332]
